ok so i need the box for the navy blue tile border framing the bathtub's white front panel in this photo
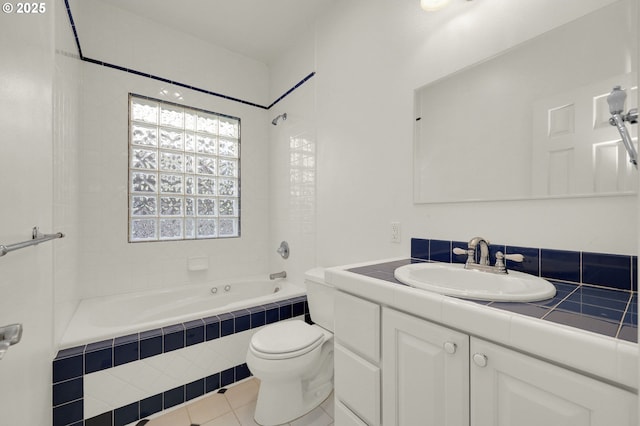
[52,295,311,426]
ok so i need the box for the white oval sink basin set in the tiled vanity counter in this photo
[394,263,556,302]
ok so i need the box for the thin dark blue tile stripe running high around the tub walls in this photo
[64,0,316,110]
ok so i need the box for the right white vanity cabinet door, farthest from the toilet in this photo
[470,338,637,426]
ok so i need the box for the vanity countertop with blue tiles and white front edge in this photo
[325,259,638,389]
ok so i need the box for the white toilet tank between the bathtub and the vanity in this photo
[304,268,335,333]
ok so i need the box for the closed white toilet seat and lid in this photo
[250,320,324,359]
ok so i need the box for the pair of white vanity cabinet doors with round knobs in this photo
[380,307,637,426]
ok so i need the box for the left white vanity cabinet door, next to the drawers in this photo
[382,308,470,426]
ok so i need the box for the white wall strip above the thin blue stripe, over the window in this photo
[69,0,269,105]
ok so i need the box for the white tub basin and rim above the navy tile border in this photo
[59,279,306,349]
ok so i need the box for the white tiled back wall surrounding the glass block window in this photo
[71,1,275,297]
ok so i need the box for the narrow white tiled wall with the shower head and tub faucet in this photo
[268,28,321,282]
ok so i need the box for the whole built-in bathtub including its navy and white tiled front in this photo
[52,279,308,425]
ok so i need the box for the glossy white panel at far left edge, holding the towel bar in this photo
[0,1,57,425]
